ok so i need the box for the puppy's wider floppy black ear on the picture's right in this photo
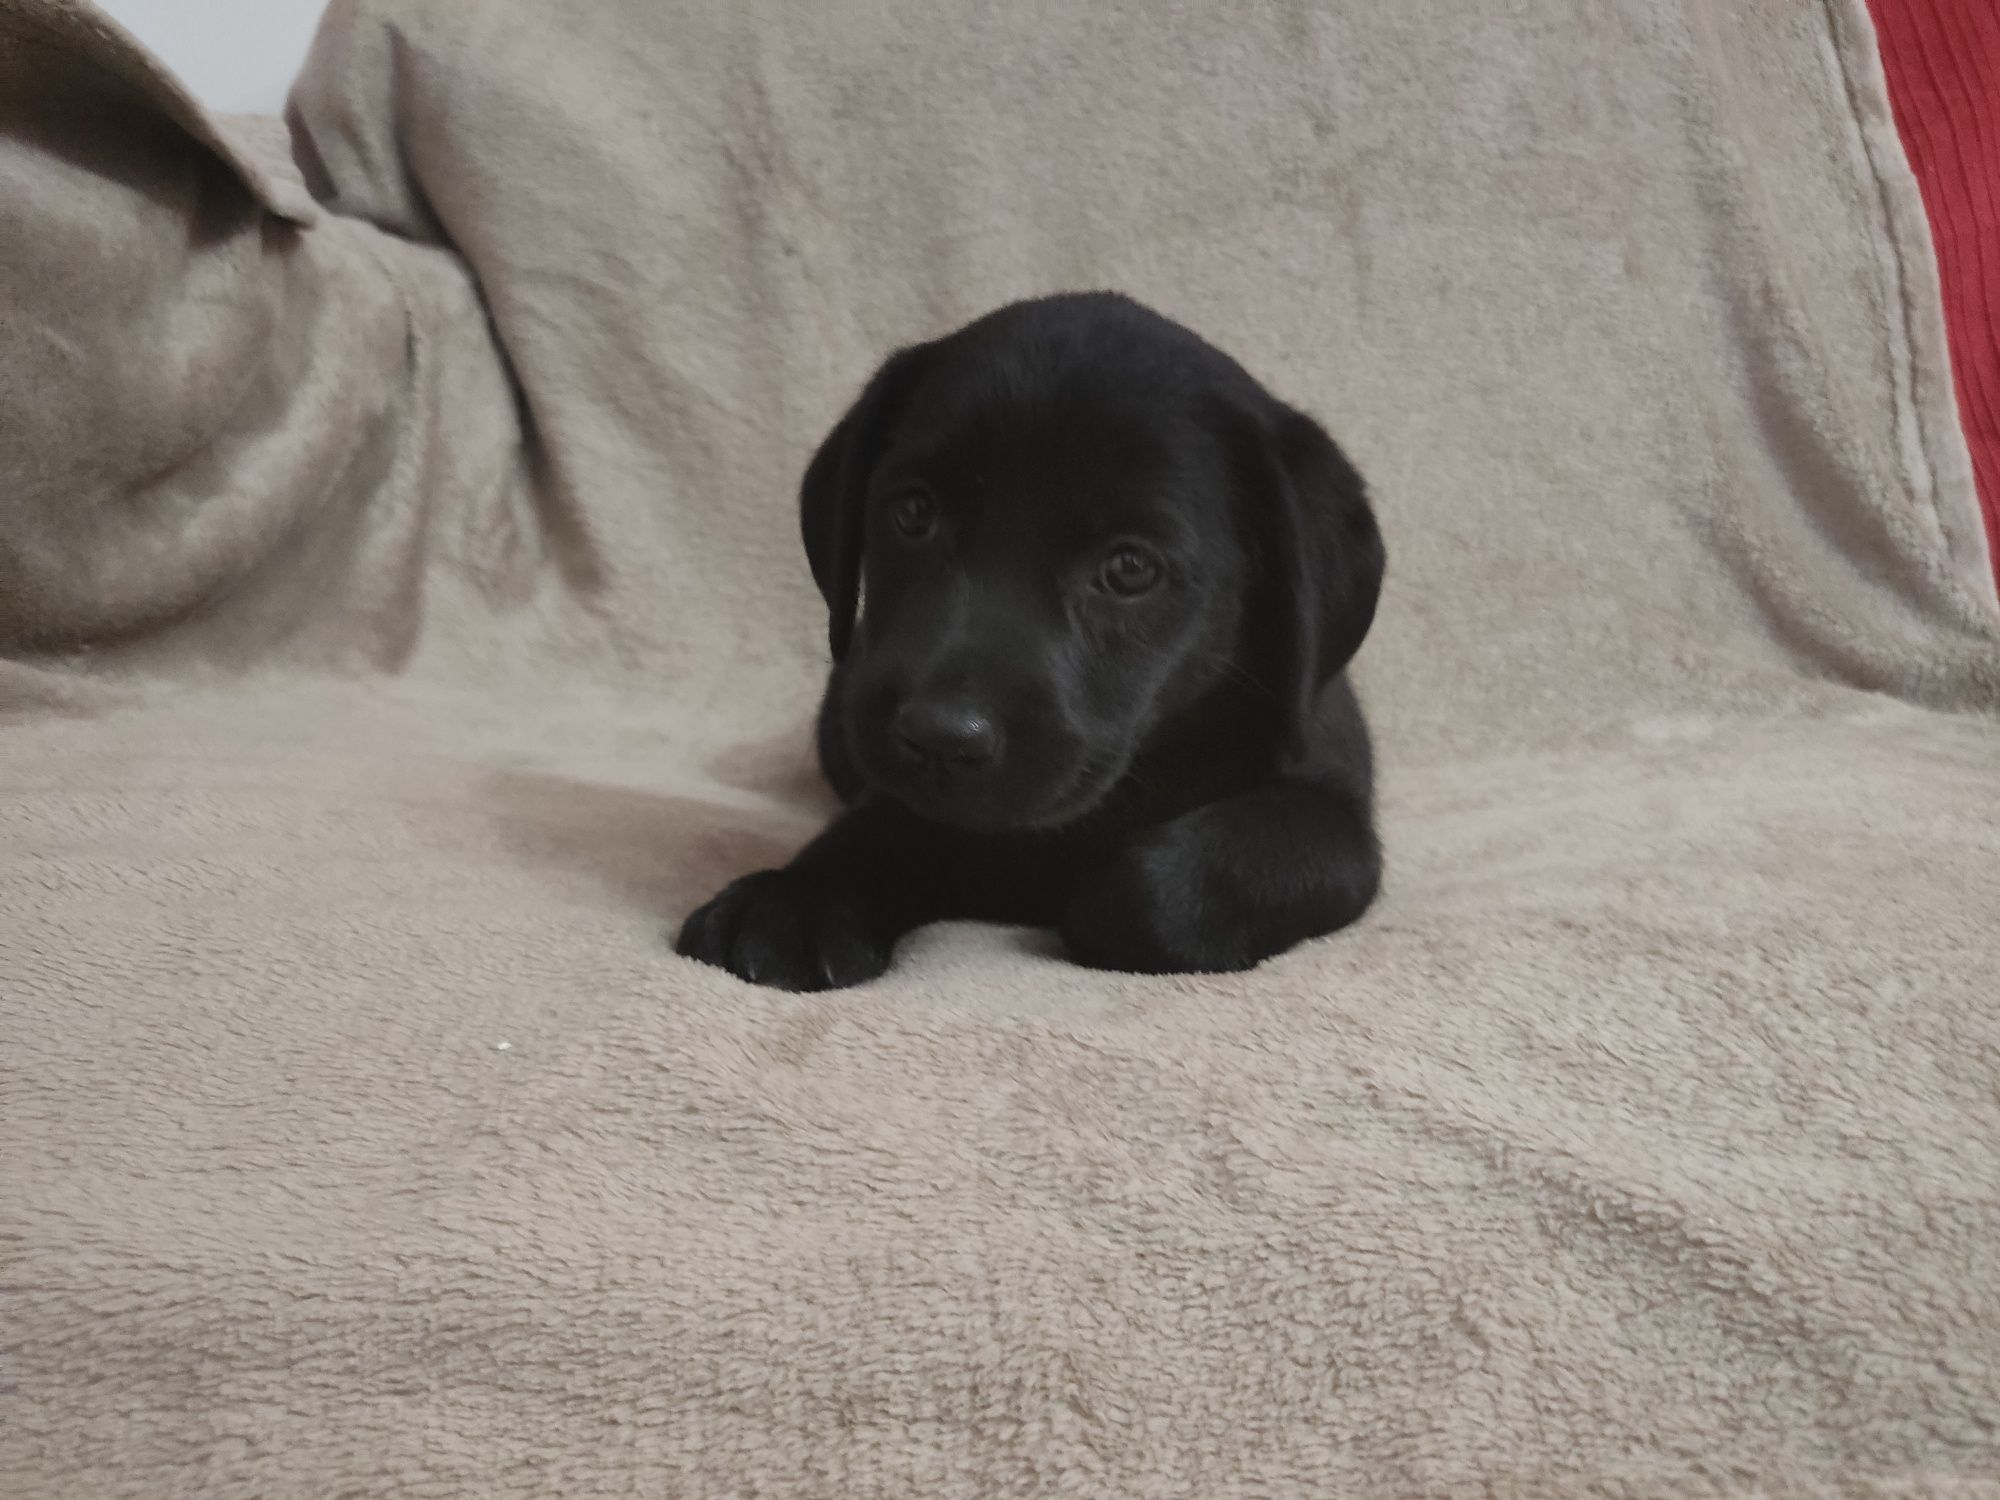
[1238,400,1386,748]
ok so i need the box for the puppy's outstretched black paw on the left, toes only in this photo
[674,870,888,990]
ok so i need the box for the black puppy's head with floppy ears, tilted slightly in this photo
[800,294,1382,828]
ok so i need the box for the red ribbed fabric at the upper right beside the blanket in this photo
[1868,0,2000,586]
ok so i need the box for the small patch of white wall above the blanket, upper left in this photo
[98,0,326,114]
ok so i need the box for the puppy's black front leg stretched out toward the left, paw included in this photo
[674,798,940,990]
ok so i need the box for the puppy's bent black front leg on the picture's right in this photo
[1062,782,1382,974]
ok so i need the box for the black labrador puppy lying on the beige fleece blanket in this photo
[678,294,1384,990]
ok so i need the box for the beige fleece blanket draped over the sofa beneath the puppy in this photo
[0,0,2000,1500]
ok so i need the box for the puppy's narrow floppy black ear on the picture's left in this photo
[798,346,922,662]
